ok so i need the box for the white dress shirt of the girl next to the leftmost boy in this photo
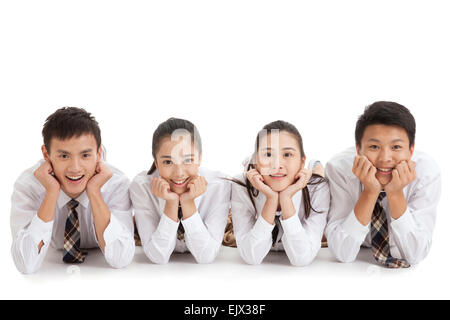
[130,168,231,264]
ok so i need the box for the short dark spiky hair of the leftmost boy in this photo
[42,107,102,153]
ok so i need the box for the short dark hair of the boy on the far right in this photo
[355,101,416,148]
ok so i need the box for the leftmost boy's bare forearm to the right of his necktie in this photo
[87,191,111,251]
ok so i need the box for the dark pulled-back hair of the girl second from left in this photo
[147,118,202,175]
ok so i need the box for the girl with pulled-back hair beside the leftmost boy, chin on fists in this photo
[130,118,231,264]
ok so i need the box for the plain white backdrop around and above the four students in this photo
[0,0,450,299]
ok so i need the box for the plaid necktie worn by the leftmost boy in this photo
[63,199,87,263]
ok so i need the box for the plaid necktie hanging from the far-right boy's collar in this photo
[370,191,409,268]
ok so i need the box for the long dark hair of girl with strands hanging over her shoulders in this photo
[229,120,325,218]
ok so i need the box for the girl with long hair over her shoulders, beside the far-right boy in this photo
[231,121,330,266]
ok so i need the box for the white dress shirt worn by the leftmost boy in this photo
[11,160,135,273]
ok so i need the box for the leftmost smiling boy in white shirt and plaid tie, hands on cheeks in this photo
[11,107,134,273]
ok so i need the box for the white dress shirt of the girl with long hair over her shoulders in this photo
[231,161,330,266]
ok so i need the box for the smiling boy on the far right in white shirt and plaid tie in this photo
[325,101,441,268]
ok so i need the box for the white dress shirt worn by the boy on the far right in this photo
[325,147,441,264]
